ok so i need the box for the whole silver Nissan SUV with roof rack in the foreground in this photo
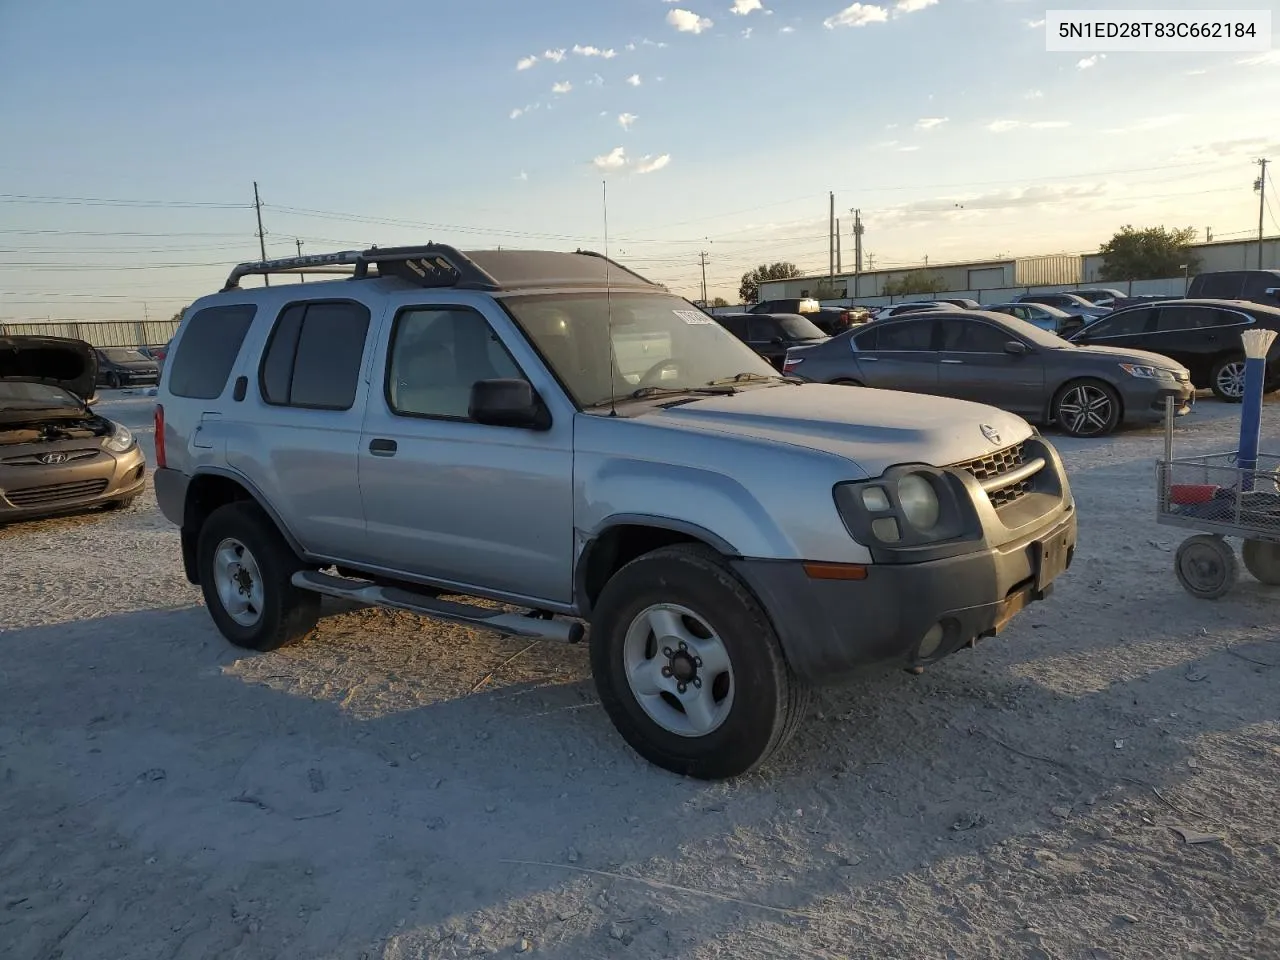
[155,244,1076,778]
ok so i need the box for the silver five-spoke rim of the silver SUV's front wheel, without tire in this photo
[622,603,735,737]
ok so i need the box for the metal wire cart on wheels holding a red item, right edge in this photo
[1156,399,1280,600]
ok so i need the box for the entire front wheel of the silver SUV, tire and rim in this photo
[590,544,809,780]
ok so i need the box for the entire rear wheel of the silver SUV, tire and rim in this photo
[196,500,320,650]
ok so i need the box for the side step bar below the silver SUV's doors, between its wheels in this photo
[293,570,586,644]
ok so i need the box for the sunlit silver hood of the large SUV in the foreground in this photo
[645,384,1032,476]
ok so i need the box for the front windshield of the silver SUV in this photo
[502,293,778,407]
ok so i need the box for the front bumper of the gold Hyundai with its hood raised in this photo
[0,445,147,524]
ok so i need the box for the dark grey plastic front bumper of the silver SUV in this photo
[733,504,1076,684]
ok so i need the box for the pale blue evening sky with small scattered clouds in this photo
[0,0,1280,319]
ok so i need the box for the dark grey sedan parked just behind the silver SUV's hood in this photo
[785,311,1194,436]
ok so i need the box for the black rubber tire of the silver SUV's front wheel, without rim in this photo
[590,544,809,780]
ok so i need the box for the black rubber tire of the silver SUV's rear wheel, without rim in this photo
[196,500,320,650]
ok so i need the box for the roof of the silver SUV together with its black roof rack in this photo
[223,243,658,291]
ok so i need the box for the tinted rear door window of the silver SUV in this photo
[259,301,369,410]
